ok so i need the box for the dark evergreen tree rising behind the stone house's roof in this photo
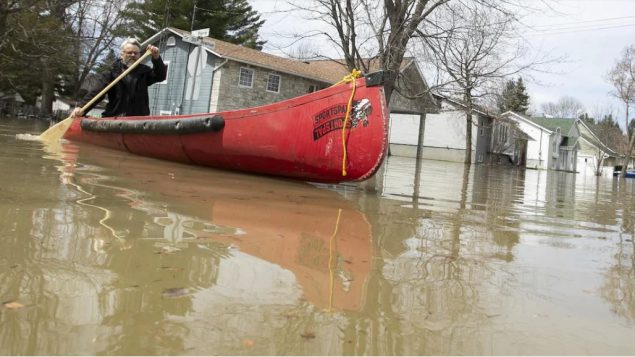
[121,0,265,50]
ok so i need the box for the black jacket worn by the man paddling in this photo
[82,57,167,117]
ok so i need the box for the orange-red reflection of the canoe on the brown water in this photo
[62,140,372,311]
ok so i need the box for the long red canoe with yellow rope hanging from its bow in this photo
[64,73,388,183]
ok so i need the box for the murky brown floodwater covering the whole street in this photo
[0,119,635,355]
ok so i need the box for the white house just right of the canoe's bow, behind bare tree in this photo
[390,95,493,164]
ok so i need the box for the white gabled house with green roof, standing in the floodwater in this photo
[492,111,580,172]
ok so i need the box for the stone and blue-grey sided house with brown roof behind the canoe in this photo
[143,28,346,115]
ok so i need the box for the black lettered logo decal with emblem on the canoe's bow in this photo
[313,98,372,140]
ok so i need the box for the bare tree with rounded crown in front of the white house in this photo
[420,3,539,164]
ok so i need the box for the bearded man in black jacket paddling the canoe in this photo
[71,38,167,117]
